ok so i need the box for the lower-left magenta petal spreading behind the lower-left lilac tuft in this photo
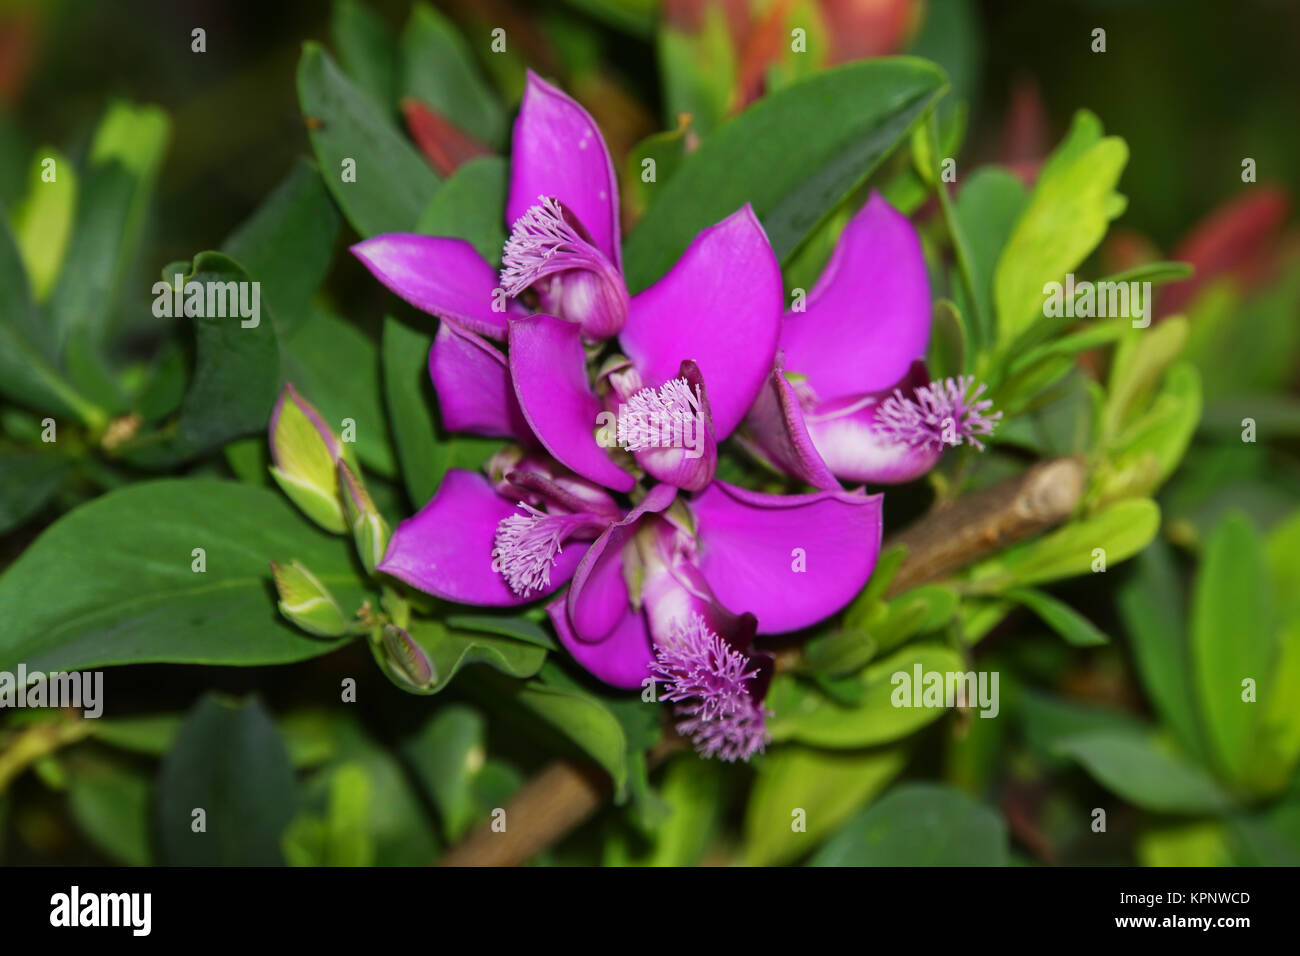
[377,468,588,607]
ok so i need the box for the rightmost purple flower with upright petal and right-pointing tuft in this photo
[745,193,1001,489]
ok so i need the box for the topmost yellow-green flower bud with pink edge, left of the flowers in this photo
[268,382,356,535]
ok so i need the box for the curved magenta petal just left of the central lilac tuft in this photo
[510,313,636,492]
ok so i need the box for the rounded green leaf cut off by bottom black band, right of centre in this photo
[809,783,1008,866]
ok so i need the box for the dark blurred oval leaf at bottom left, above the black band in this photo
[156,695,298,866]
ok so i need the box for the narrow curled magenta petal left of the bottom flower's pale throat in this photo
[568,485,677,643]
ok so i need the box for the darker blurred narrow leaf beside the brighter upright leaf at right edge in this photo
[1115,540,1205,760]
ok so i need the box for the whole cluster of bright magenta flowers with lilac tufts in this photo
[352,74,996,760]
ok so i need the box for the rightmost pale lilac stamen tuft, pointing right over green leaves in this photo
[876,376,1002,451]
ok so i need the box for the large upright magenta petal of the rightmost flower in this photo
[781,193,930,399]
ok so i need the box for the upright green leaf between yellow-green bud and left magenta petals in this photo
[381,317,501,507]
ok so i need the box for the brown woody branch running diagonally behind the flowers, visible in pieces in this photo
[437,458,1086,866]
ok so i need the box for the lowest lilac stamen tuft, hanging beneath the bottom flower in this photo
[650,614,768,762]
